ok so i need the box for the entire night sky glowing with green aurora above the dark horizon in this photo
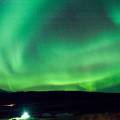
[0,0,120,92]
